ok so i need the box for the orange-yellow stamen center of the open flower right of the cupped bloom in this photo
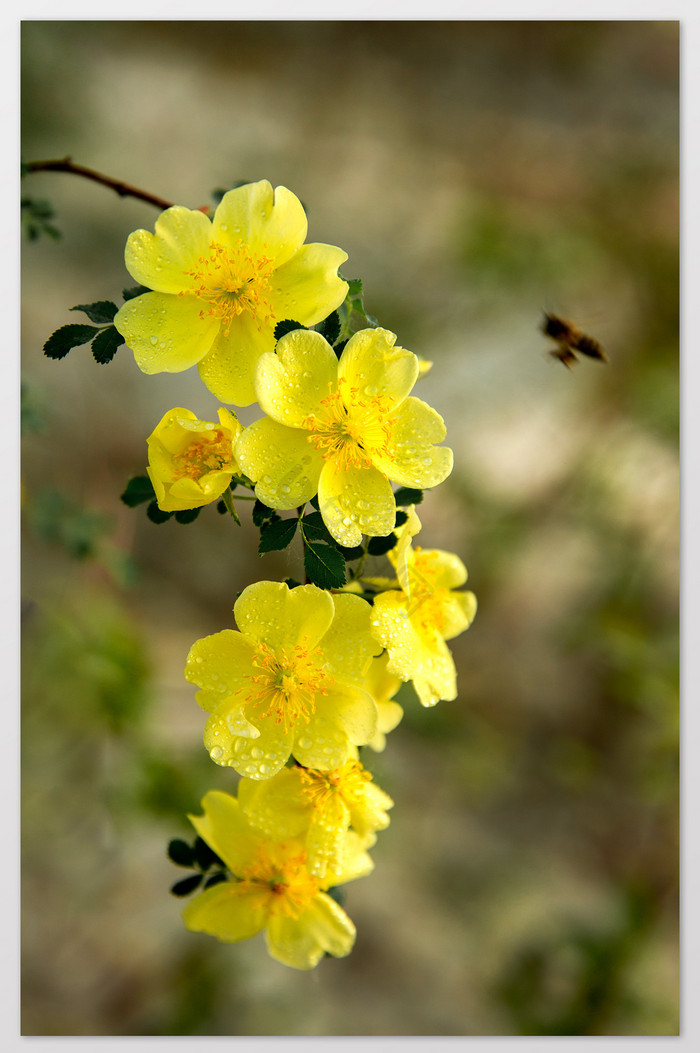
[302,377,392,471]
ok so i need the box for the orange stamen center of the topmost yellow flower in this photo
[179,241,274,336]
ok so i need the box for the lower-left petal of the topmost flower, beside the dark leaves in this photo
[114,293,220,374]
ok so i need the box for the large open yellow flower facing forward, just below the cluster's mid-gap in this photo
[185,581,379,779]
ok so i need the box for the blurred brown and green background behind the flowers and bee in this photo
[22,21,679,1036]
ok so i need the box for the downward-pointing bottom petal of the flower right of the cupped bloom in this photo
[318,457,396,549]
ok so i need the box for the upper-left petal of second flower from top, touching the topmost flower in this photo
[256,330,338,428]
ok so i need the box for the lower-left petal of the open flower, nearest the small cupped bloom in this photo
[235,417,323,510]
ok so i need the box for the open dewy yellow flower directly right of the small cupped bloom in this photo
[236,329,453,548]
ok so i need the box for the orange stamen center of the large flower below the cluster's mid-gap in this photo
[246,643,333,734]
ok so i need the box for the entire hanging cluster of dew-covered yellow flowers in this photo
[114,180,476,969]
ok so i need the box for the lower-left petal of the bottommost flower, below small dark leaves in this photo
[182,881,272,943]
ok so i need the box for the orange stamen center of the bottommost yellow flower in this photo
[238,845,319,918]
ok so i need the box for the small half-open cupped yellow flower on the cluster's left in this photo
[147,408,241,512]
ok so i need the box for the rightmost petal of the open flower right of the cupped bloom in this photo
[372,395,453,489]
